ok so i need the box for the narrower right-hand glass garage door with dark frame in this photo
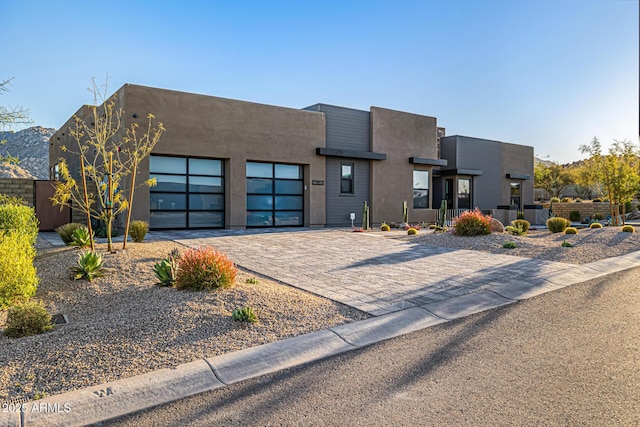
[246,162,304,227]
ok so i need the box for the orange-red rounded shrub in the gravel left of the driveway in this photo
[176,246,238,291]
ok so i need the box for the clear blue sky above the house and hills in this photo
[0,0,640,163]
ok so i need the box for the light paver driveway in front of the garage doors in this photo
[164,230,576,315]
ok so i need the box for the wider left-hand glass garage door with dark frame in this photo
[149,156,224,229]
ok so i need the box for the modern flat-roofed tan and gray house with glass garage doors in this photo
[50,84,533,229]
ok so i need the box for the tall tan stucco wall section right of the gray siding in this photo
[371,107,437,224]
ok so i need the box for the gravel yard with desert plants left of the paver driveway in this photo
[0,241,368,402]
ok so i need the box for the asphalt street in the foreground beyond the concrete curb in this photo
[100,267,640,426]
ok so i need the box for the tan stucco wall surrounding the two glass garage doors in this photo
[123,85,325,228]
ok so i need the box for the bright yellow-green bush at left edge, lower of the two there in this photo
[0,231,39,309]
